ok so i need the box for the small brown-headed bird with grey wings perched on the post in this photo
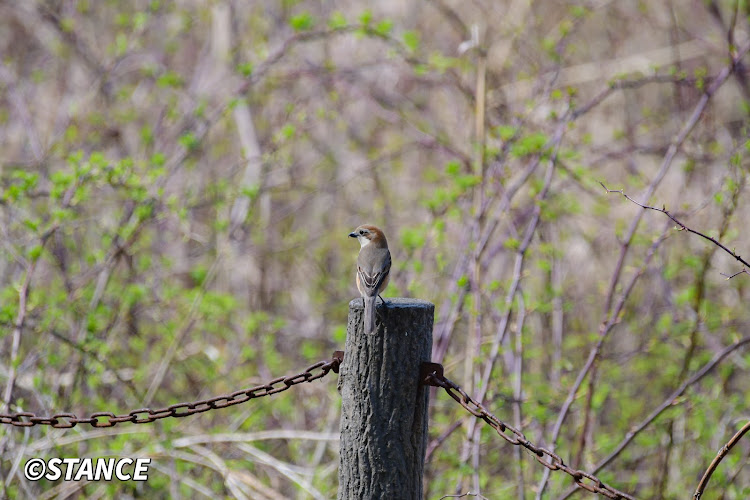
[349,224,391,333]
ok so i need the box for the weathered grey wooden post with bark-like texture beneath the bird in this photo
[338,299,435,500]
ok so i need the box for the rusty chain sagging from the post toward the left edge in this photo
[0,351,344,429]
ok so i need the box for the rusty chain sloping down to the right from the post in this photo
[420,363,635,500]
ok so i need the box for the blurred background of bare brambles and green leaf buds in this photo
[0,0,750,499]
